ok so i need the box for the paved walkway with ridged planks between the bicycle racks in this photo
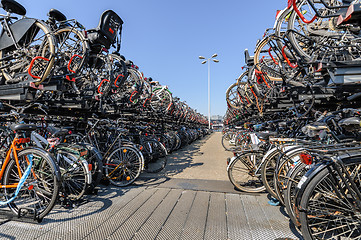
[0,133,301,240]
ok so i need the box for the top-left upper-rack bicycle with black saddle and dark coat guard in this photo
[0,0,56,86]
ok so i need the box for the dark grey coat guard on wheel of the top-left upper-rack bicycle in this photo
[0,18,37,51]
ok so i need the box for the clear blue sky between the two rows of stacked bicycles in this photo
[13,0,287,115]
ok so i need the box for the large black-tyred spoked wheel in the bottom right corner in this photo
[298,163,361,239]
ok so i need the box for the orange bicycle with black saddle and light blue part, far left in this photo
[0,124,60,222]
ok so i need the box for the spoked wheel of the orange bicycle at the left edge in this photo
[4,148,59,220]
